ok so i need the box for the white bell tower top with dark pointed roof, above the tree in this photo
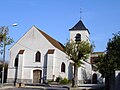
[69,20,90,42]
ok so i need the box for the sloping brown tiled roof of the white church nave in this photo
[37,28,64,51]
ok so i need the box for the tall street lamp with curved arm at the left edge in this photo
[1,23,17,86]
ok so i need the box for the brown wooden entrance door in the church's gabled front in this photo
[33,70,42,83]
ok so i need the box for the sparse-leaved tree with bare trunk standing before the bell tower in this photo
[64,41,92,87]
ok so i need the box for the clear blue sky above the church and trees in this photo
[0,0,120,60]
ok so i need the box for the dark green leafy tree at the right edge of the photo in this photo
[96,32,120,90]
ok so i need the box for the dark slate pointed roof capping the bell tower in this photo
[69,20,90,33]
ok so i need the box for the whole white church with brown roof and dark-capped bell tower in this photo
[7,20,92,83]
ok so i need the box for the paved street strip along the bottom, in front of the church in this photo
[0,84,104,90]
